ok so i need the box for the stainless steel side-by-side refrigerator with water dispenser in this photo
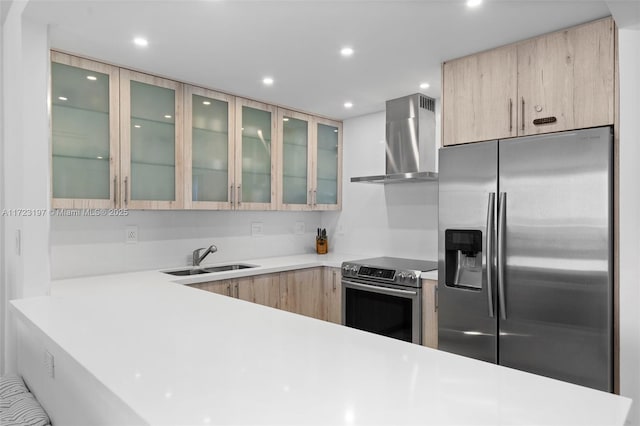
[438,127,613,391]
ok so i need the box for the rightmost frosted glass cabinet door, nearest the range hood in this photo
[313,118,342,210]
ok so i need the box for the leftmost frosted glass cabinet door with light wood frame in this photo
[51,52,119,209]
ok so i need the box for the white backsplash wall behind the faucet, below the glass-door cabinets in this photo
[51,211,320,279]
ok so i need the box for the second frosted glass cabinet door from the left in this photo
[120,70,184,209]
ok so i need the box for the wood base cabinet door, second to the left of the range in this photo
[280,268,326,320]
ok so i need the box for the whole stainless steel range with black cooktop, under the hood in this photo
[342,257,438,344]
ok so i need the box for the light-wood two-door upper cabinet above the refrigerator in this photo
[442,18,615,146]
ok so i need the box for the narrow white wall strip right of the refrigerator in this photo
[618,28,640,425]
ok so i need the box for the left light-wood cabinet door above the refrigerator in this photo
[442,45,518,146]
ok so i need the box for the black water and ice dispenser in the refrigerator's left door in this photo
[445,229,482,290]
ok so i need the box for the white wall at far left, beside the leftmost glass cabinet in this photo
[1,2,50,371]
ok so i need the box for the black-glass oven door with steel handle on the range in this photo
[342,278,422,344]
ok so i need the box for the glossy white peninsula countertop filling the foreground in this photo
[11,255,630,425]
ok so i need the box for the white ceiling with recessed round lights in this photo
[25,0,610,119]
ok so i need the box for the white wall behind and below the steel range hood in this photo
[322,112,440,260]
